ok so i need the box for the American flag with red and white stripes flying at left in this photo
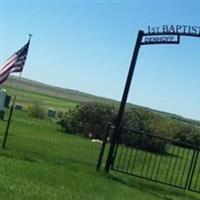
[0,39,30,84]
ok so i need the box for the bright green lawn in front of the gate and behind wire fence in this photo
[0,111,200,200]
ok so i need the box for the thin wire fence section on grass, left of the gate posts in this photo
[0,97,101,166]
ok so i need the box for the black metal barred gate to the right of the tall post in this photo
[103,126,200,192]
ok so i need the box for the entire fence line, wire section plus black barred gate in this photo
[0,94,200,192]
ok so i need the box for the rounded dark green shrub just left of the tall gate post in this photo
[58,103,116,139]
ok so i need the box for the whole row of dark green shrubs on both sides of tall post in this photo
[58,102,200,153]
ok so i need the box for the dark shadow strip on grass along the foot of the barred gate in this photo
[104,174,200,200]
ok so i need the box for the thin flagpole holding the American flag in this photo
[2,34,33,149]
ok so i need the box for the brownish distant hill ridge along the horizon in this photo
[4,76,200,127]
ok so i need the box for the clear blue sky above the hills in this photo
[0,0,200,119]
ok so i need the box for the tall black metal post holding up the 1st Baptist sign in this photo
[105,30,144,172]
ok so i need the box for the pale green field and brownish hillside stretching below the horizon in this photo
[3,76,200,127]
